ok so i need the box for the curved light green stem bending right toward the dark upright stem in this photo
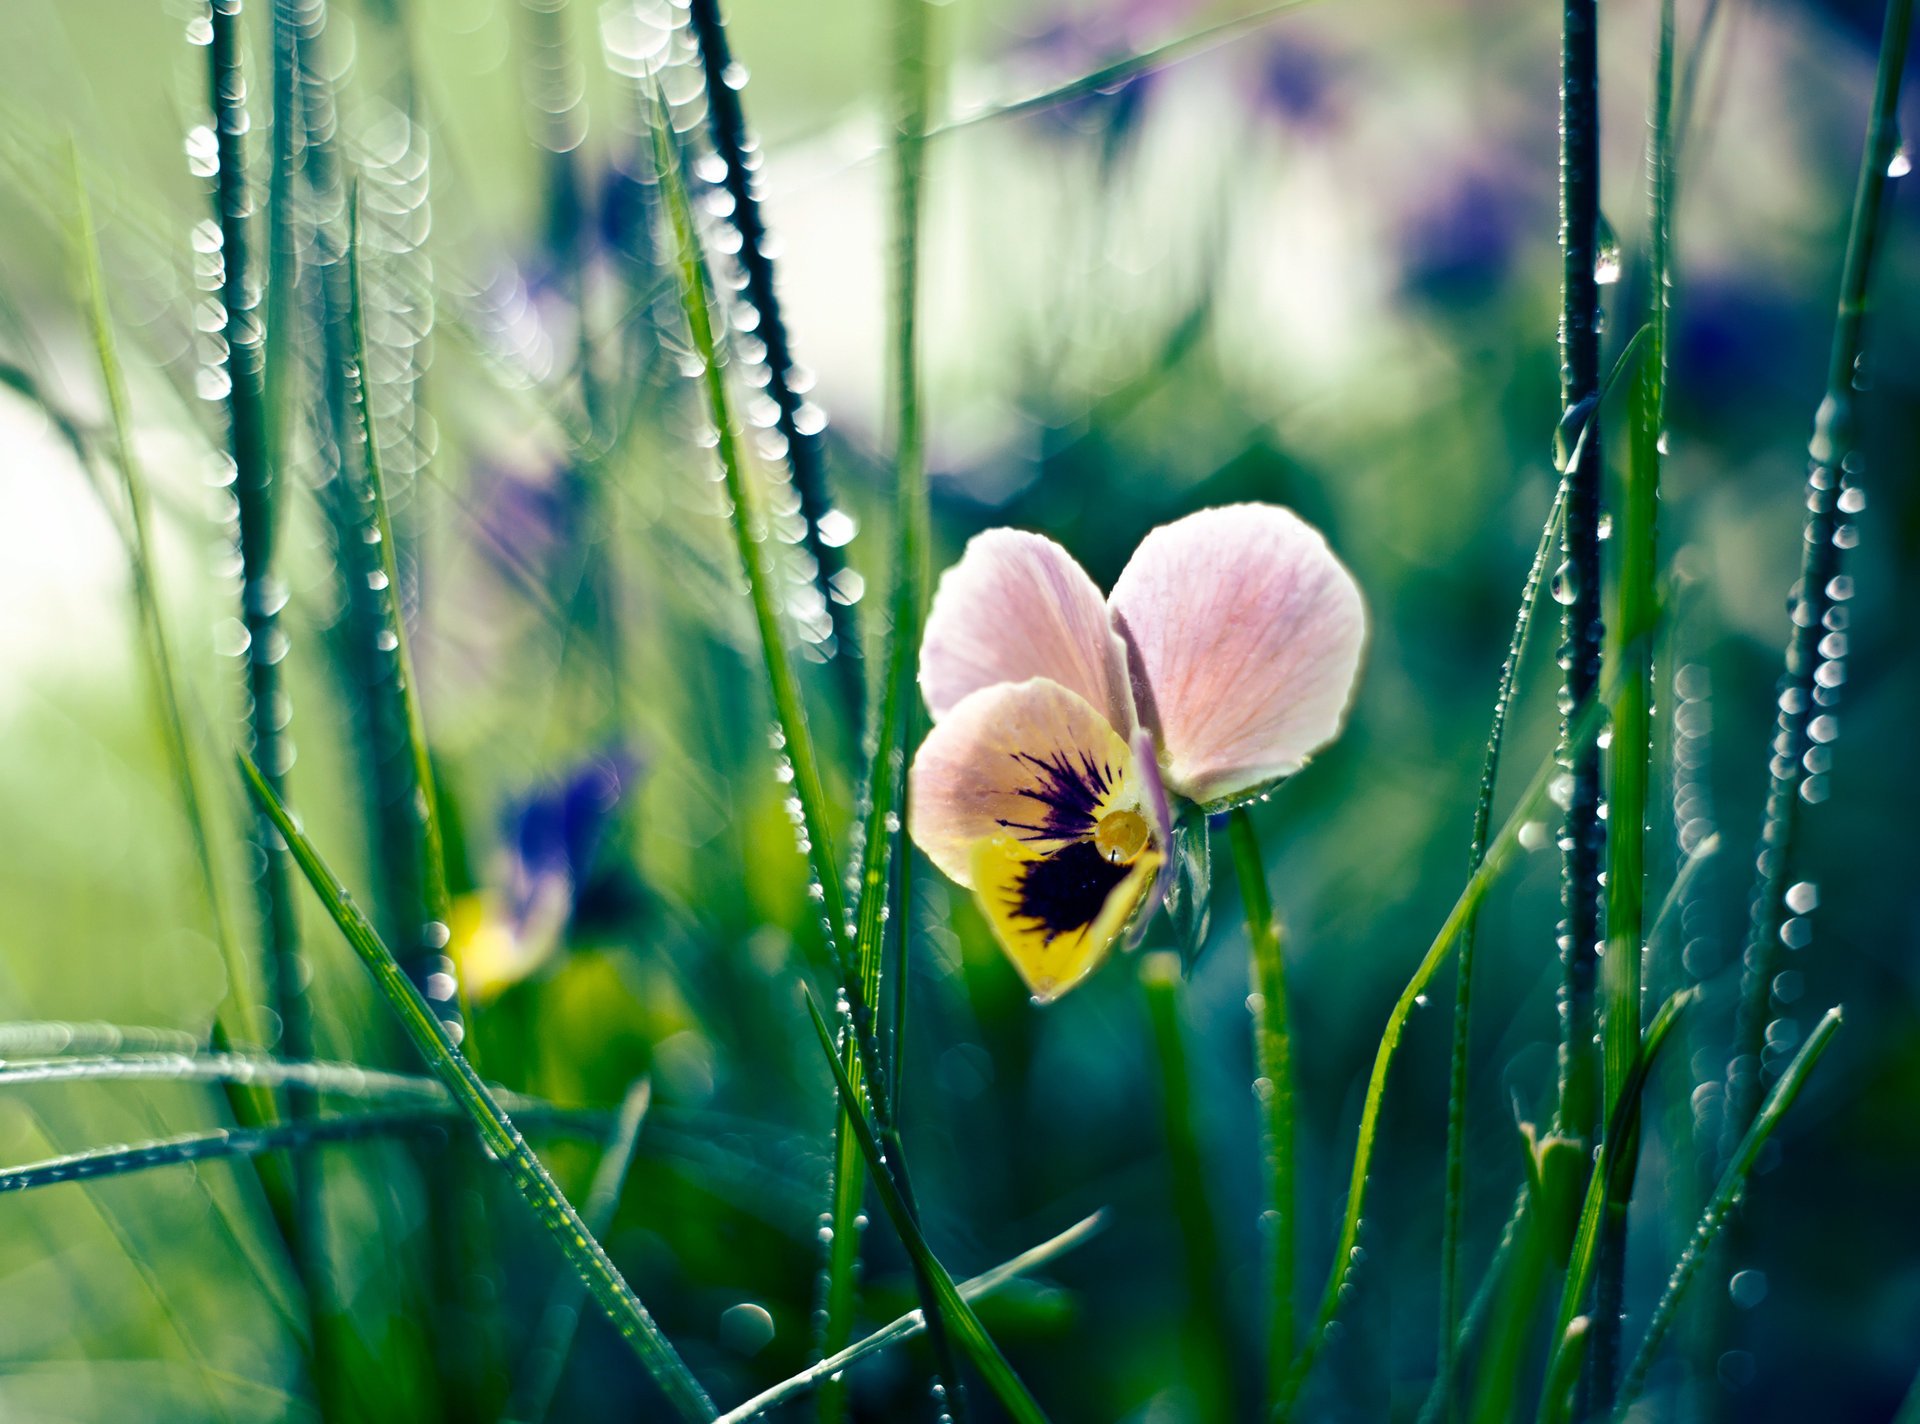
[1273,699,1605,1420]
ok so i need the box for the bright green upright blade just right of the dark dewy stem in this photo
[1589,0,1674,1412]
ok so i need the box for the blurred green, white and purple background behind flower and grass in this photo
[0,0,1920,1422]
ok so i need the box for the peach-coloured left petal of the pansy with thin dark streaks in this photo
[908,677,1139,887]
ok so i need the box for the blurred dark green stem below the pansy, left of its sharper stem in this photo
[1140,951,1236,1420]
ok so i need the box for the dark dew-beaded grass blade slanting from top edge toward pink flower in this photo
[687,0,867,727]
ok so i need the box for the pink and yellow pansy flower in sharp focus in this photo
[910,505,1367,1000]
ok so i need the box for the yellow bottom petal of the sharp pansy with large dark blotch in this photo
[970,831,1164,1002]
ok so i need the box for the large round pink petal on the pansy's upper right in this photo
[1108,505,1367,802]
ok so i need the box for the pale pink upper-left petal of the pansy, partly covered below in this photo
[920,530,1131,727]
